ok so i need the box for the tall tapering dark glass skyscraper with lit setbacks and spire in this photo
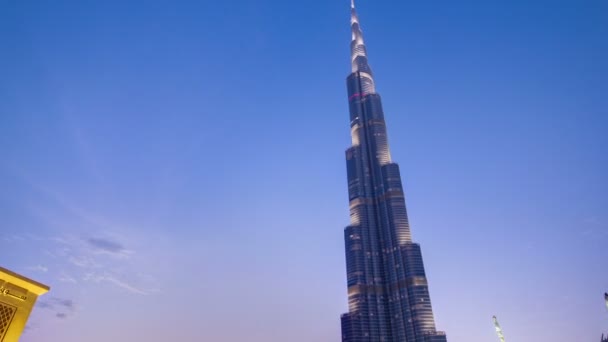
[341,0,446,342]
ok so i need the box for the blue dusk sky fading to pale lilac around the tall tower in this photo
[0,0,608,342]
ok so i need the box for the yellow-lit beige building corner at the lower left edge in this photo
[0,267,49,342]
